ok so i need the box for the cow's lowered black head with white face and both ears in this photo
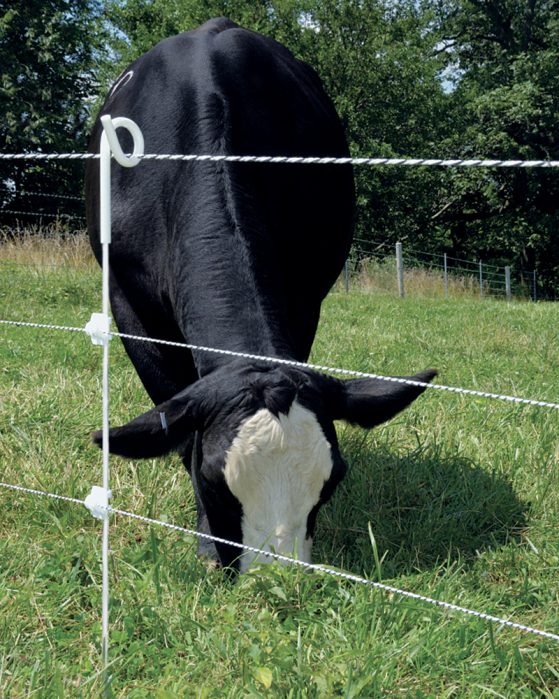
[94,365,436,571]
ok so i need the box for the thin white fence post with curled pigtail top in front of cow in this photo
[94,115,144,695]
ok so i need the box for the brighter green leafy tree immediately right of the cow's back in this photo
[300,0,449,253]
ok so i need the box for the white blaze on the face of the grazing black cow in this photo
[224,402,333,572]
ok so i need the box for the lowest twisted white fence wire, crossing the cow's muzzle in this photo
[0,482,559,641]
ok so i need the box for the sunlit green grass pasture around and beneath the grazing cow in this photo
[0,249,559,699]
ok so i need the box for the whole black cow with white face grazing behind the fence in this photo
[86,19,434,570]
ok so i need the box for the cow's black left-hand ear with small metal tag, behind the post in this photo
[92,388,207,459]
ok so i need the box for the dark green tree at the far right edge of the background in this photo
[424,0,559,294]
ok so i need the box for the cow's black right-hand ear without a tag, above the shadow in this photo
[334,369,437,427]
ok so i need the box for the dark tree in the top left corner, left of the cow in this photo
[0,0,106,223]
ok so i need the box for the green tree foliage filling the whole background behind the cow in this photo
[0,0,559,293]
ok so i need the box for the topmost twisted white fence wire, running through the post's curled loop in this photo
[0,152,559,168]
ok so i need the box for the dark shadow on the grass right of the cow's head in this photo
[313,442,529,578]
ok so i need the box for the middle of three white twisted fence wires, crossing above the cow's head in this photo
[0,320,559,410]
